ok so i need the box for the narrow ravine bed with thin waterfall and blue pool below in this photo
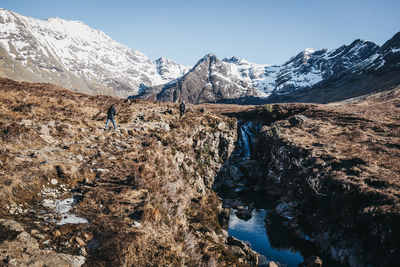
[217,121,328,267]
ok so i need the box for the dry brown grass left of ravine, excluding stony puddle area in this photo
[0,79,247,266]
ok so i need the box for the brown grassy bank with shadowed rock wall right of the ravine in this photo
[214,87,400,266]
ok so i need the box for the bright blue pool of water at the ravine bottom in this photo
[228,209,304,267]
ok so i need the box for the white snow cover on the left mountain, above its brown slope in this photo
[0,9,187,95]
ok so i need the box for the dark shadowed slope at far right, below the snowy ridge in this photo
[266,32,400,103]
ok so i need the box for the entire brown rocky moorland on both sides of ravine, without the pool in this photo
[0,76,400,266]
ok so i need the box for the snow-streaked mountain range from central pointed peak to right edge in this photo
[138,33,400,103]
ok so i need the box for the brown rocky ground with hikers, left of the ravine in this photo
[0,79,257,266]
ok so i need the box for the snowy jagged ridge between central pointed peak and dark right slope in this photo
[223,40,379,95]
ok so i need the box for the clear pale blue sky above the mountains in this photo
[0,0,400,65]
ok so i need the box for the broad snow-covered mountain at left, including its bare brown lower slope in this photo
[0,9,187,97]
